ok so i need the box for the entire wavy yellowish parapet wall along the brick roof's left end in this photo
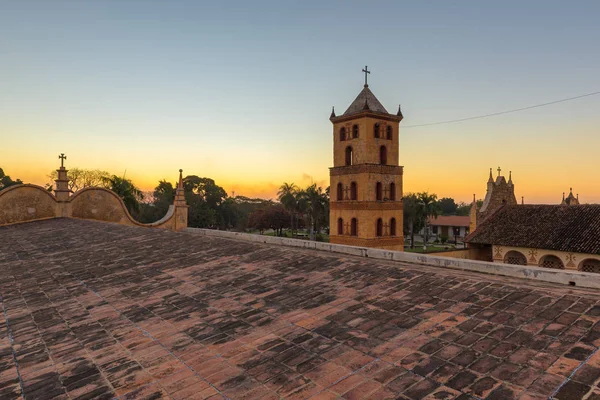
[0,184,187,231]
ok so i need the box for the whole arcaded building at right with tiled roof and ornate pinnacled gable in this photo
[466,169,600,273]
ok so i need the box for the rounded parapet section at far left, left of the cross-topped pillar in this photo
[0,184,58,225]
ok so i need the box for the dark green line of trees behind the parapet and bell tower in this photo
[0,164,482,246]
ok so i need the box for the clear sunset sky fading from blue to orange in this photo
[0,0,600,203]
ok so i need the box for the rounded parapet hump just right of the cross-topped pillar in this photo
[69,187,144,226]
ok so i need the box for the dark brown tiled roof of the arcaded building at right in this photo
[467,204,600,254]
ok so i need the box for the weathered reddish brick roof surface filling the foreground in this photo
[0,219,600,400]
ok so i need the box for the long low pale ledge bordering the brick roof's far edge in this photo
[184,228,600,289]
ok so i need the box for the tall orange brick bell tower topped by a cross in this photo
[329,67,404,250]
